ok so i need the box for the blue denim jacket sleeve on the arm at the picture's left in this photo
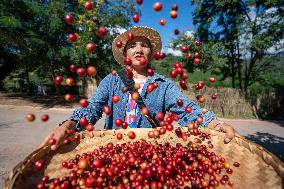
[71,74,112,124]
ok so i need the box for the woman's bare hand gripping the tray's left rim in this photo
[38,120,76,150]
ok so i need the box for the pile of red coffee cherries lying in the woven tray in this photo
[37,128,240,189]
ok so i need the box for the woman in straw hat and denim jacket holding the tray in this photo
[40,26,240,149]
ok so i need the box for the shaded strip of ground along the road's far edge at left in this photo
[0,93,82,108]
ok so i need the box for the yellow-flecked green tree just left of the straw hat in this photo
[64,0,136,79]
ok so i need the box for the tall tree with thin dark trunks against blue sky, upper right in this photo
[187,0,284,91]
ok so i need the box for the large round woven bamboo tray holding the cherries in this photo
[4,128,284,189]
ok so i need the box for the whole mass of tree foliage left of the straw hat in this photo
[0,0,136,93]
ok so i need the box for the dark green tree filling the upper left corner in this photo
[0,0,70,92]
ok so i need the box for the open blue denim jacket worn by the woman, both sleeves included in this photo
[71,73,216,129]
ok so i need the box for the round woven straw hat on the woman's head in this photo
[112,26,162,65]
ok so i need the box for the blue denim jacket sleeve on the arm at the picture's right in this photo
[165,81,216,126]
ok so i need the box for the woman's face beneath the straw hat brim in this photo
[125,37,152,67]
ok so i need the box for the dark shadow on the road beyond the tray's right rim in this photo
[246,132,284,162]
